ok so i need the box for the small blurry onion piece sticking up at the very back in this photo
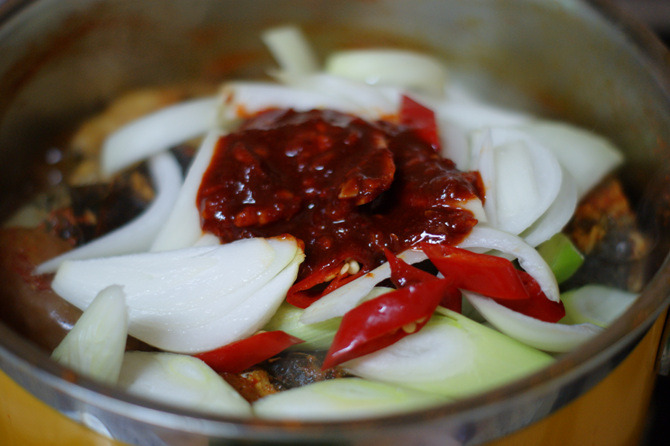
[261,26,319,74]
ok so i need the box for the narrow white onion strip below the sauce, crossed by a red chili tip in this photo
[300,249,428,324]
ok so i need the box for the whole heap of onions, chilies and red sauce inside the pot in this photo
[0,27,645,420]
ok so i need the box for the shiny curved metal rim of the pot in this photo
[0,0,670,440]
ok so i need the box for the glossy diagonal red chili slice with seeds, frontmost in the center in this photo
[322,278,454,370]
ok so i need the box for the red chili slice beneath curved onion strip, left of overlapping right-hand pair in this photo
[421,243,530,299]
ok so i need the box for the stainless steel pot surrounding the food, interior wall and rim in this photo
[0,0,670,445]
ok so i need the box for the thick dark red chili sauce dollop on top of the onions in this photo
[197,110,483,286]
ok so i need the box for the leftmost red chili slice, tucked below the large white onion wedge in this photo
[194,330,305,373]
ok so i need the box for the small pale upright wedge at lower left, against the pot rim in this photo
[51,285,128,384]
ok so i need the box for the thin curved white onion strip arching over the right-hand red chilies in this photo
[458,225,560,302]
